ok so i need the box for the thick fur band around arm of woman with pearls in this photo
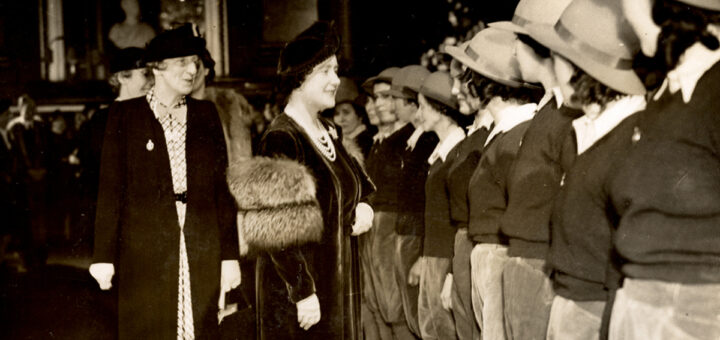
[227,157,323,250]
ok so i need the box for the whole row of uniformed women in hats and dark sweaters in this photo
[361,0,720,339]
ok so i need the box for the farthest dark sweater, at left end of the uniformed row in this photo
[365,124,415,212]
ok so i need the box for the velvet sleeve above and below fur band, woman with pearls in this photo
[260,130,315,303]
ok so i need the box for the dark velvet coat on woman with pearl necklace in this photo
[257,114,374,340]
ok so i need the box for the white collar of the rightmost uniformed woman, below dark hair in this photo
[654,29,720,103]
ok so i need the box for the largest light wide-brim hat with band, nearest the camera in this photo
[527,0,646,94]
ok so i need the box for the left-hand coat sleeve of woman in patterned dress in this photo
[93,103,130,263]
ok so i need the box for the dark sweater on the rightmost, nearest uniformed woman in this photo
[610,63,720,283]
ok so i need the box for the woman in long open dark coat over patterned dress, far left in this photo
[90,30,240,339]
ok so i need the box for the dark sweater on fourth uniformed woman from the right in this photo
[468,121,530,244]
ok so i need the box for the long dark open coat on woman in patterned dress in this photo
[93,97,239,339]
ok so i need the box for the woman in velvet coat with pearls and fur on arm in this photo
[228,22,374,340]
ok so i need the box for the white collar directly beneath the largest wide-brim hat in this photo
[572,95,646,155]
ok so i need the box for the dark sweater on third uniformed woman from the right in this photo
[500,104,582,259]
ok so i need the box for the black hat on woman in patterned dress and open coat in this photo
[145,24,205,62]
